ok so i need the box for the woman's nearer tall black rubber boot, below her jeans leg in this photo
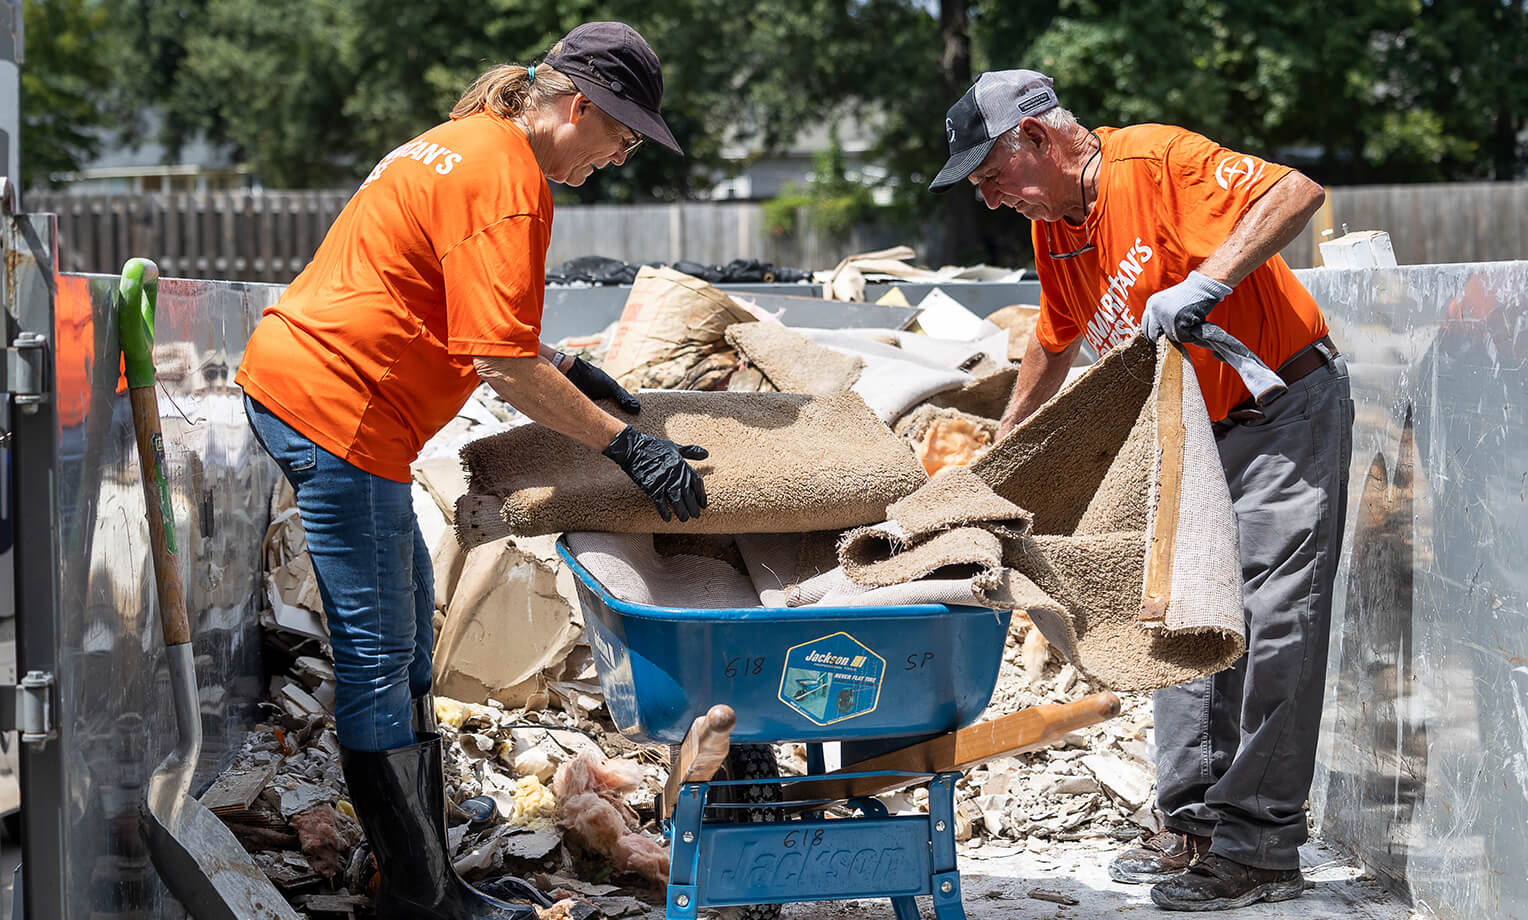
[339,734,536,920]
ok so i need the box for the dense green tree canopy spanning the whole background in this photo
[14,0,1528,255]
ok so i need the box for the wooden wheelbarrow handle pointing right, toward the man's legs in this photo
[782,692,1120,801]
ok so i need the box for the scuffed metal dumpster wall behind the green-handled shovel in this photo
[48,268,281,917]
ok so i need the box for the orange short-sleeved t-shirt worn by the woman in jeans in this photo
[234,113,552,483]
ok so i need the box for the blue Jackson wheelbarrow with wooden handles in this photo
[558,541,1120,920]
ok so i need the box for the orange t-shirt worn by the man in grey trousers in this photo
[1033,124,1326,419]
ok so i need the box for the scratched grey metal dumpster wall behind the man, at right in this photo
[1297,261,1528,918]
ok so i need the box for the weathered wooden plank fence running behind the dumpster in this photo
[23,182,1528,283]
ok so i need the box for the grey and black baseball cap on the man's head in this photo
[929,70,1060,191]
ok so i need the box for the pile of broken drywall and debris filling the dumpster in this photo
[226,251,1157,918]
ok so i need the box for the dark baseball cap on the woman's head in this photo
[542,23,685,156]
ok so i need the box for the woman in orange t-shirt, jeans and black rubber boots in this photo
[235,23,706,920]
